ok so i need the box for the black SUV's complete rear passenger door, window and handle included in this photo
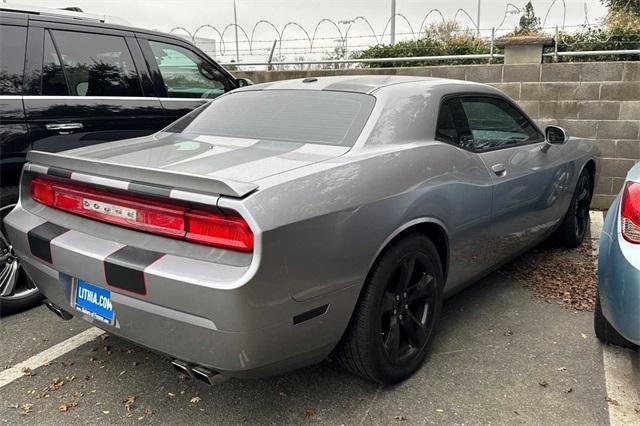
[24,21,163,152]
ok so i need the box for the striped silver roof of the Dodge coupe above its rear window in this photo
[240,75,484,93]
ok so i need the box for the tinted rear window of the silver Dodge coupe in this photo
[166,90,375,146]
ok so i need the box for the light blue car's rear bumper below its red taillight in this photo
[598,202,640,345]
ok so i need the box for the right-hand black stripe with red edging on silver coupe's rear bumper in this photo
[104,246,164,295]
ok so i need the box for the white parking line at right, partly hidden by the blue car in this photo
[591,211,640,426]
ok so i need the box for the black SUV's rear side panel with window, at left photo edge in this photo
[0,17,29,188]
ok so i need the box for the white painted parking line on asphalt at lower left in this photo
[0,327,104,388]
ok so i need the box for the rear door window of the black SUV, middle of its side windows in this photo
[50,31,142,96]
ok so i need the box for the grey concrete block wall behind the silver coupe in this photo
[235,62,640,209]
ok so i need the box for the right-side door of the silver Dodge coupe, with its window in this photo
[460,95,570,261]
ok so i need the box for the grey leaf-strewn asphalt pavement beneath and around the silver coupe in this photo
[0,264,640,425]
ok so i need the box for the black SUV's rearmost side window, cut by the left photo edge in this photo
[0,25,27,95]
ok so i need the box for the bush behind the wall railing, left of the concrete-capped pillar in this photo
[353,22,491,68]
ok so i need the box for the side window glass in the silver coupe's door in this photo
[461,96,544,151]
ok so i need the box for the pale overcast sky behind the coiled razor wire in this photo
[8,0,606,62]
